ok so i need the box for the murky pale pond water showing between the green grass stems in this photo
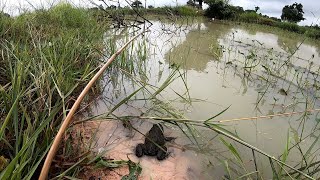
[89,20,320,179]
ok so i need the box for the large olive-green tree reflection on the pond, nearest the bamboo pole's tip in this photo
[165,22,231,71]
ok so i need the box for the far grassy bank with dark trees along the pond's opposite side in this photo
[87,0,320,39]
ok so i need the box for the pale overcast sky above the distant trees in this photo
[0,0,320,25]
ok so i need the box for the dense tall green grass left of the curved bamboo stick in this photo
[0,4,103,179]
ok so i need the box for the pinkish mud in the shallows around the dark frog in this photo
[86,121,206,179]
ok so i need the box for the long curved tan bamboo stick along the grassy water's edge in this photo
[39,30,148,180]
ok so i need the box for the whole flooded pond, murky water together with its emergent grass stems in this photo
[85,20,320,179]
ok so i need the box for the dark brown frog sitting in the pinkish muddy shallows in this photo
[136,124,175,161]
